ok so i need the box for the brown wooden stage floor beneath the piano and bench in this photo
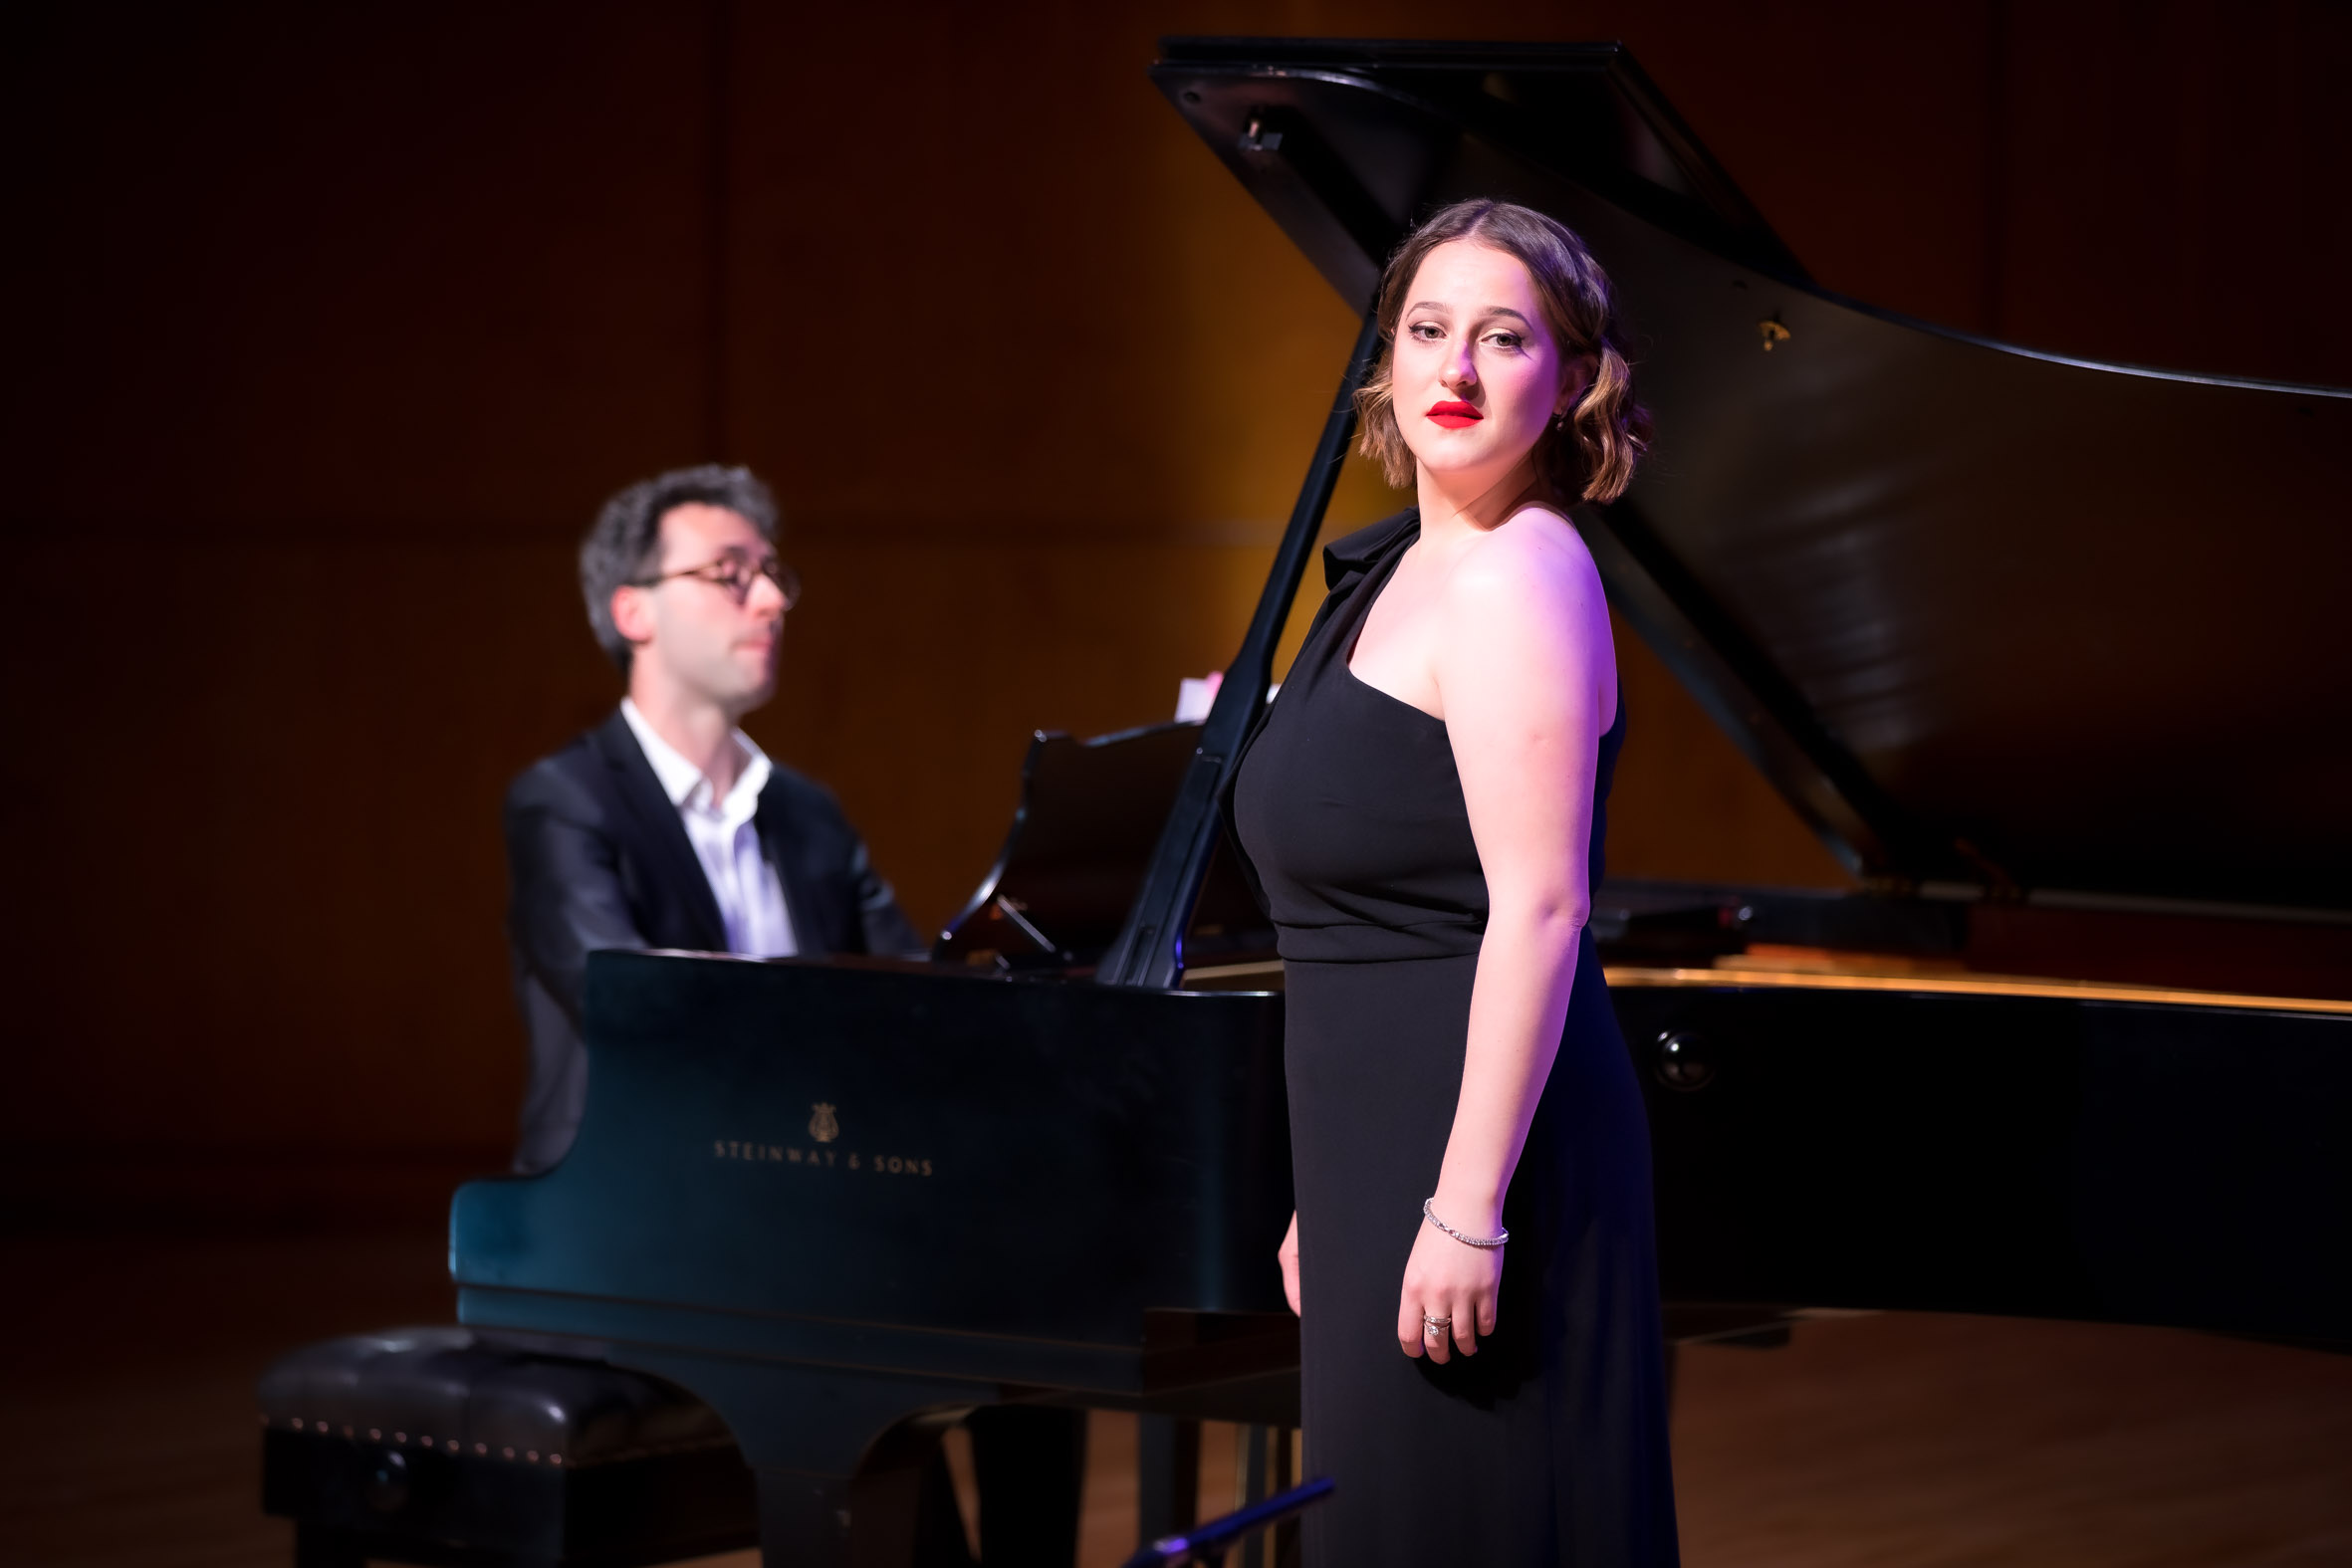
[0,1232,2352,1568]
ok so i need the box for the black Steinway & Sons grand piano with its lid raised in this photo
[452,40,2352,1563]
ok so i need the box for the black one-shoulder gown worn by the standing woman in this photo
[1230,513,1675,1568]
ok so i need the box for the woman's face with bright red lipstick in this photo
[1390,240,1583,489]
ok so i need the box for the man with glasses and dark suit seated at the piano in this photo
[506,466,924,1173]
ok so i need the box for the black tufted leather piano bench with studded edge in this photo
[259,1328,760,1568]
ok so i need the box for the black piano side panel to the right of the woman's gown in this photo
[1611,974,2352,1347]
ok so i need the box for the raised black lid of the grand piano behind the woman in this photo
[1152,40,2352,919]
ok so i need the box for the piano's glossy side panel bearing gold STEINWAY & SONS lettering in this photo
[452,952,1289,1394]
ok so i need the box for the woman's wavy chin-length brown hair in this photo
[1355,200,1651,501]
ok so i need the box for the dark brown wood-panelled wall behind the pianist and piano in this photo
[0,0,2352,1223]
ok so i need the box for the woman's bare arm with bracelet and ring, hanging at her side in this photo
[1397,510,1616,1361]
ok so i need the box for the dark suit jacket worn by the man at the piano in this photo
[506,710,924,1171]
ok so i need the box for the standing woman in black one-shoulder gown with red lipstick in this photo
[1233,202,1675,1568]
